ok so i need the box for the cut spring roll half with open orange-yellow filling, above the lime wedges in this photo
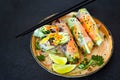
[39,32,70,51]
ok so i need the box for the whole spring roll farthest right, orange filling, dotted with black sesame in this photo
[77,8,103,46]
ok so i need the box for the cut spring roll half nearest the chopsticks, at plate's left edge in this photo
[33,25,58,39]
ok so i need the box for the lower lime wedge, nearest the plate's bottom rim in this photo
[52,64,76,74]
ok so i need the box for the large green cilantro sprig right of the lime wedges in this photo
[78,55,104,69]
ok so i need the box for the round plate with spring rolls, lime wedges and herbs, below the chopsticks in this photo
[31,8,113,77]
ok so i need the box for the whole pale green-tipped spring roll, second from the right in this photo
[67,18,93,53]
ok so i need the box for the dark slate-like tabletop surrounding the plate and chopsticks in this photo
[0,0,120,80]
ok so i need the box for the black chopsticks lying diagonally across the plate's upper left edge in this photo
[16,0,96,38]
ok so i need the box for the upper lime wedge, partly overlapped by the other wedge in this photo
[49,54,67,64]
